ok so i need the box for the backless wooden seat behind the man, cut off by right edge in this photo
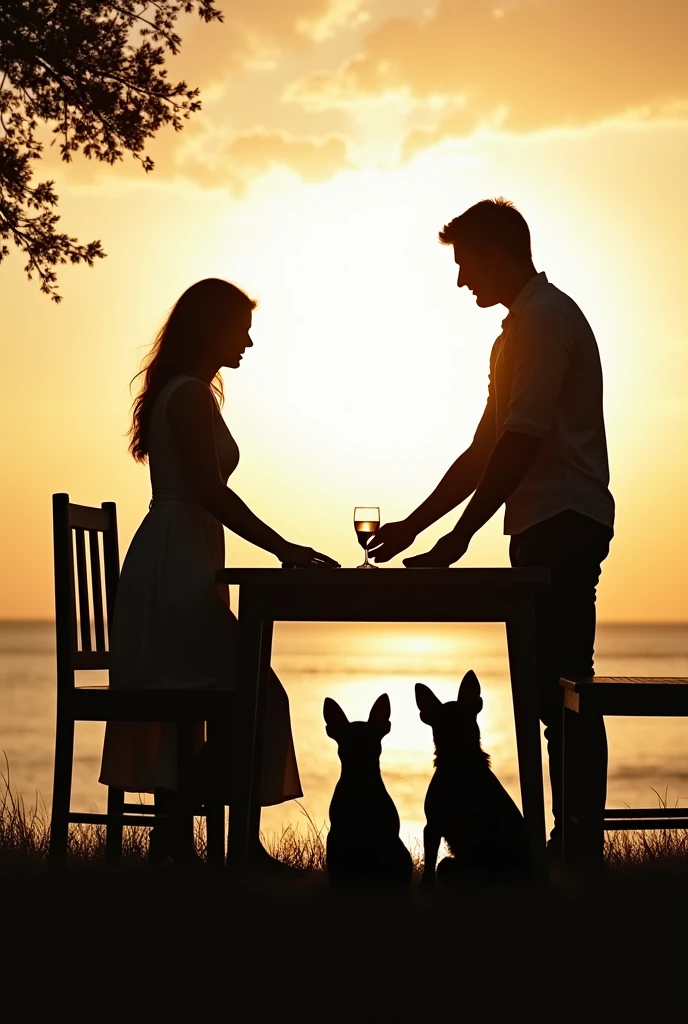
[559,676,688,859]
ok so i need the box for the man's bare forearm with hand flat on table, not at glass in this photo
[404,430,543,568]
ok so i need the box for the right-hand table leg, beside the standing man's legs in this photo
[507,601,547,877]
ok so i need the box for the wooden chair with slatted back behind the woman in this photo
[50,494,233,864]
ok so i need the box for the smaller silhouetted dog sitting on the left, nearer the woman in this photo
[323,693,414,886]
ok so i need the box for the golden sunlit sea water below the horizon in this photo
[0,622,688,844]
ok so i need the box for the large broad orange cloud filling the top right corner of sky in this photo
[286,0,688,140]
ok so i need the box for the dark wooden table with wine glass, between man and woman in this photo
[216,568,549,872]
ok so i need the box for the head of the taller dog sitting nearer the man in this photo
[416,672,482,755]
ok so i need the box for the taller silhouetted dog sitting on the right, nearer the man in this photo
[416,672,530,884]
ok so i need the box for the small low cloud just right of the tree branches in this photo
[177,128,349,195]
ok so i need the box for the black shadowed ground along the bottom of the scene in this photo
[0,865,688,1024]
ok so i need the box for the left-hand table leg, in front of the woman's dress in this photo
[227,593,263,867]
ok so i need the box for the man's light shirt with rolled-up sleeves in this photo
[475,273,614,535]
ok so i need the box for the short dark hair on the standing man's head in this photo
[439,196,531,259]
